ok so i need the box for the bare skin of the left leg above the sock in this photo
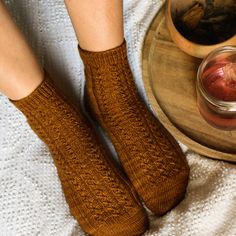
[0,1,43,100]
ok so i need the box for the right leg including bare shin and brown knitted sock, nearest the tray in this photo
[65,0,189,215]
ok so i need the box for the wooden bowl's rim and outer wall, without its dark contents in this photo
[165,0,236,58]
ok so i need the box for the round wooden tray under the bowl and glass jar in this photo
[142,7,236,162]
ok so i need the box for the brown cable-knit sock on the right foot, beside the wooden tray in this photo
[79,42,189,215]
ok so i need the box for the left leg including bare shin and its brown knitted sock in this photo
[0,3,148,236]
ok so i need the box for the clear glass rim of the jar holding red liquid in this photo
[197,46,236,112]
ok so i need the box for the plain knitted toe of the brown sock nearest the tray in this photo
[144,170,189,216]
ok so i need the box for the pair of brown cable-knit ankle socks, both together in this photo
[13,42,189,236]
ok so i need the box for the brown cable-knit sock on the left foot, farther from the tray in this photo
[13,73,147,236]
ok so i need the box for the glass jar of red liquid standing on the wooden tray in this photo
[196,46,236,130]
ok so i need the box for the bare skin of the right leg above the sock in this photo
[65,0,124,51]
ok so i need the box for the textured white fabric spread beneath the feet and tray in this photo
[0,0,236,236]
